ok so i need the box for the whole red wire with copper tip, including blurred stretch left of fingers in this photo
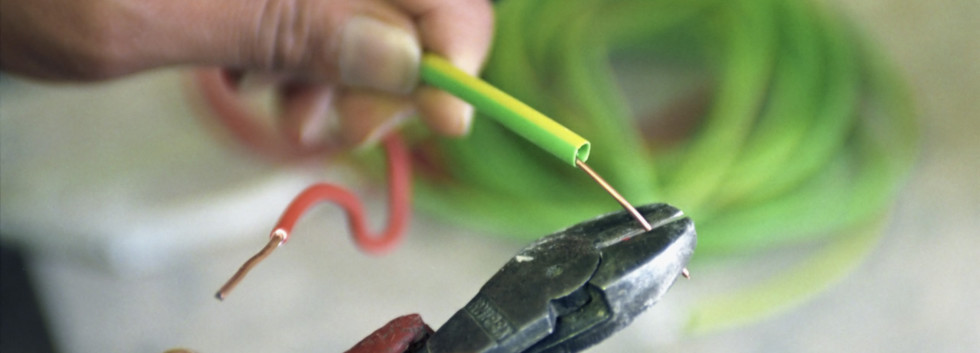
[195,70,412,299]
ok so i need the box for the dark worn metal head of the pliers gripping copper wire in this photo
[421,204,697,353]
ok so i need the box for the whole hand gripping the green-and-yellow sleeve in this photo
[0,0,493,145]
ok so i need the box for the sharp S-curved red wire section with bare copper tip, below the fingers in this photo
[215,134,412,300]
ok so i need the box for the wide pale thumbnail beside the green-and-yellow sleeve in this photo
[339,16,422,94]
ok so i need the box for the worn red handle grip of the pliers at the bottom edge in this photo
[347,314,432,353]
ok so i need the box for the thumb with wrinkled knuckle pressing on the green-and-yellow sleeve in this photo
[157,0,421,93]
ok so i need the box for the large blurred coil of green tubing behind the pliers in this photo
[406,0,917,330]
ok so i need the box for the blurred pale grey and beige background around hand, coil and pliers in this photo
[0,0,980,353]
